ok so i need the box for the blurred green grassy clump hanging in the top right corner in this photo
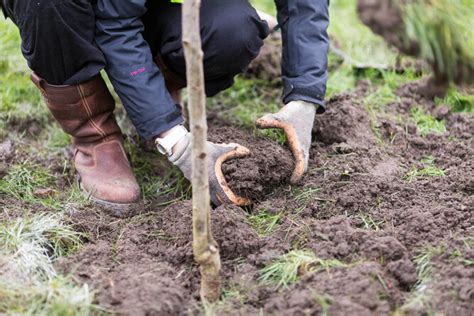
[401,0,474,82]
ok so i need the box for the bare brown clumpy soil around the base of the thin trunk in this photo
[47,78,474,315]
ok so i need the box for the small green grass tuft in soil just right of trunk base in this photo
[259,250,346,288]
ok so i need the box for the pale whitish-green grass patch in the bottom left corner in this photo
[0,213,98,315]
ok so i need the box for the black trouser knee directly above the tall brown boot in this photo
[14,0,105,85]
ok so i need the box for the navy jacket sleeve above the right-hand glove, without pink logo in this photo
[275,0,329,112]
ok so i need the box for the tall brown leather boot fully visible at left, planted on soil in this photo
[31,74,140,215]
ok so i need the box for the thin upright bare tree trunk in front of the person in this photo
[183,0,221,302]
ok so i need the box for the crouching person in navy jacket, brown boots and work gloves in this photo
[0,0,328,214]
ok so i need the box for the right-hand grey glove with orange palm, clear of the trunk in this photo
[256,101,318,184]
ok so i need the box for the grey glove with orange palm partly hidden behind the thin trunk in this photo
[168,133,250,206]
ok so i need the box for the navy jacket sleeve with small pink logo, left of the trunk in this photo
[95,0,183,139]
